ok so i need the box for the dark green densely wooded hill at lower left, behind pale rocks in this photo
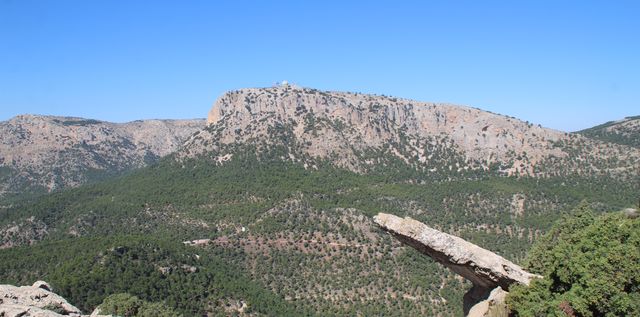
[0,236,304,316]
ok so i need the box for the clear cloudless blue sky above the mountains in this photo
[0,0,640,131]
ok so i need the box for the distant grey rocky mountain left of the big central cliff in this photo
[0,115,205,196]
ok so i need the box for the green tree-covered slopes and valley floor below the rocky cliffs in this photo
[0,150,638,316]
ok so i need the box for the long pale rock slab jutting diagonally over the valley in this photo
[374,213,541,316]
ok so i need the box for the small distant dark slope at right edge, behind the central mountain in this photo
[576,116,640,148]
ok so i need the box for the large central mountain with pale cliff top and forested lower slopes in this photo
[0,86,640,316]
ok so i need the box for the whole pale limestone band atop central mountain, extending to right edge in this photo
[183,86,640,175]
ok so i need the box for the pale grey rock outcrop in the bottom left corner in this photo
[0,281,109,317]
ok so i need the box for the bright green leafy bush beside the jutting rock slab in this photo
[508,205,640,316]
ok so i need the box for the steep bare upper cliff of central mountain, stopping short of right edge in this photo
[202,86,564,165]
